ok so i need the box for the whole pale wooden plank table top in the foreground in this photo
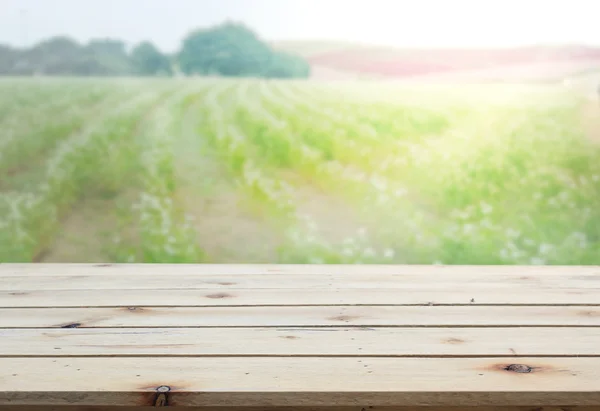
[0,264,600,410]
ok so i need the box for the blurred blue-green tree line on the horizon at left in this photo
[0,22,310,78]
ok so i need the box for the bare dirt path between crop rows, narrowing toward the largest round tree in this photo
[175,97,283,263]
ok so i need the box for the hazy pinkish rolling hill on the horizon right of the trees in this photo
[274,41,600,82]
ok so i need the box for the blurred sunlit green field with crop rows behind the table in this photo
[0,79,600,264]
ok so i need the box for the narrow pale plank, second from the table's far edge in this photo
[0,271,600,293]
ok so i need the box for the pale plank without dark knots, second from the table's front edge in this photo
[0,328,600,357]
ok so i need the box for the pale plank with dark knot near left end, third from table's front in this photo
[0,306,600,328]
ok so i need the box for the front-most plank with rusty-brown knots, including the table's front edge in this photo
[0,357,600,407]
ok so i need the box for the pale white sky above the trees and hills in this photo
[0,0,600,51]
